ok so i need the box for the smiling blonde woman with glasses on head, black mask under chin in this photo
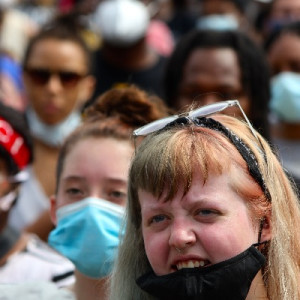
[110,100,300,300]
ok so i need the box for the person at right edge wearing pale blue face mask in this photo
[265,22,300,192]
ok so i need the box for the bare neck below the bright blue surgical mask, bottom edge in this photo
[72,270,108,300]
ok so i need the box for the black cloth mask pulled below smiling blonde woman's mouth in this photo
[136,245,265,300]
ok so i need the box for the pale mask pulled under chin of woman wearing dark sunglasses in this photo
[26,107,81,147]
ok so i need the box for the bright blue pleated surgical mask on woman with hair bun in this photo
[48,198,124,278]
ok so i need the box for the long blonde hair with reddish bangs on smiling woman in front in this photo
[110,115,300,300]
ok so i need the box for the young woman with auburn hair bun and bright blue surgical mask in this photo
[48,87,167,300]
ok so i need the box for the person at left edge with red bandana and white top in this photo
[0,103,74,286]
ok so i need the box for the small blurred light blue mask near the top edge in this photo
[197,14,239,31]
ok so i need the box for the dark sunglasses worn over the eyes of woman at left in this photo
[24,67,85,87]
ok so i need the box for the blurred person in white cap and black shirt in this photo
[89,0,166,104]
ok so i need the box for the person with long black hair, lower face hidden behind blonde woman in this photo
[164,30,270,139]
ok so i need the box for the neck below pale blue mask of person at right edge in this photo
[271,122,300,141]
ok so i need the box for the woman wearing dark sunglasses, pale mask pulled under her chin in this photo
[10,23,94,240]
